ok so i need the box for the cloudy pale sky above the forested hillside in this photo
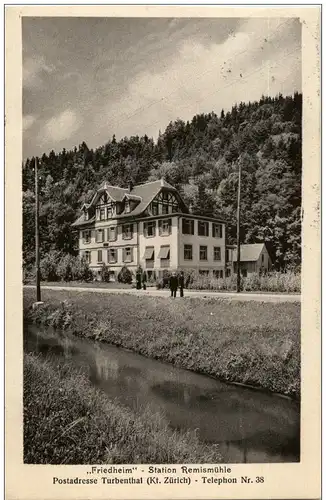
[22,17,301,158]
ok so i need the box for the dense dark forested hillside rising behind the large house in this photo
[23,94,302,269]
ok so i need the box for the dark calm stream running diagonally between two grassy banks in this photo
[24,326,300,463]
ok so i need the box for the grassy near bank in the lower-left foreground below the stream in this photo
[24,354,220,464]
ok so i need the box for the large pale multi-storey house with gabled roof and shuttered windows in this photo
[73,179,225,278]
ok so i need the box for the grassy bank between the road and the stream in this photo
[24,289,300,397]
